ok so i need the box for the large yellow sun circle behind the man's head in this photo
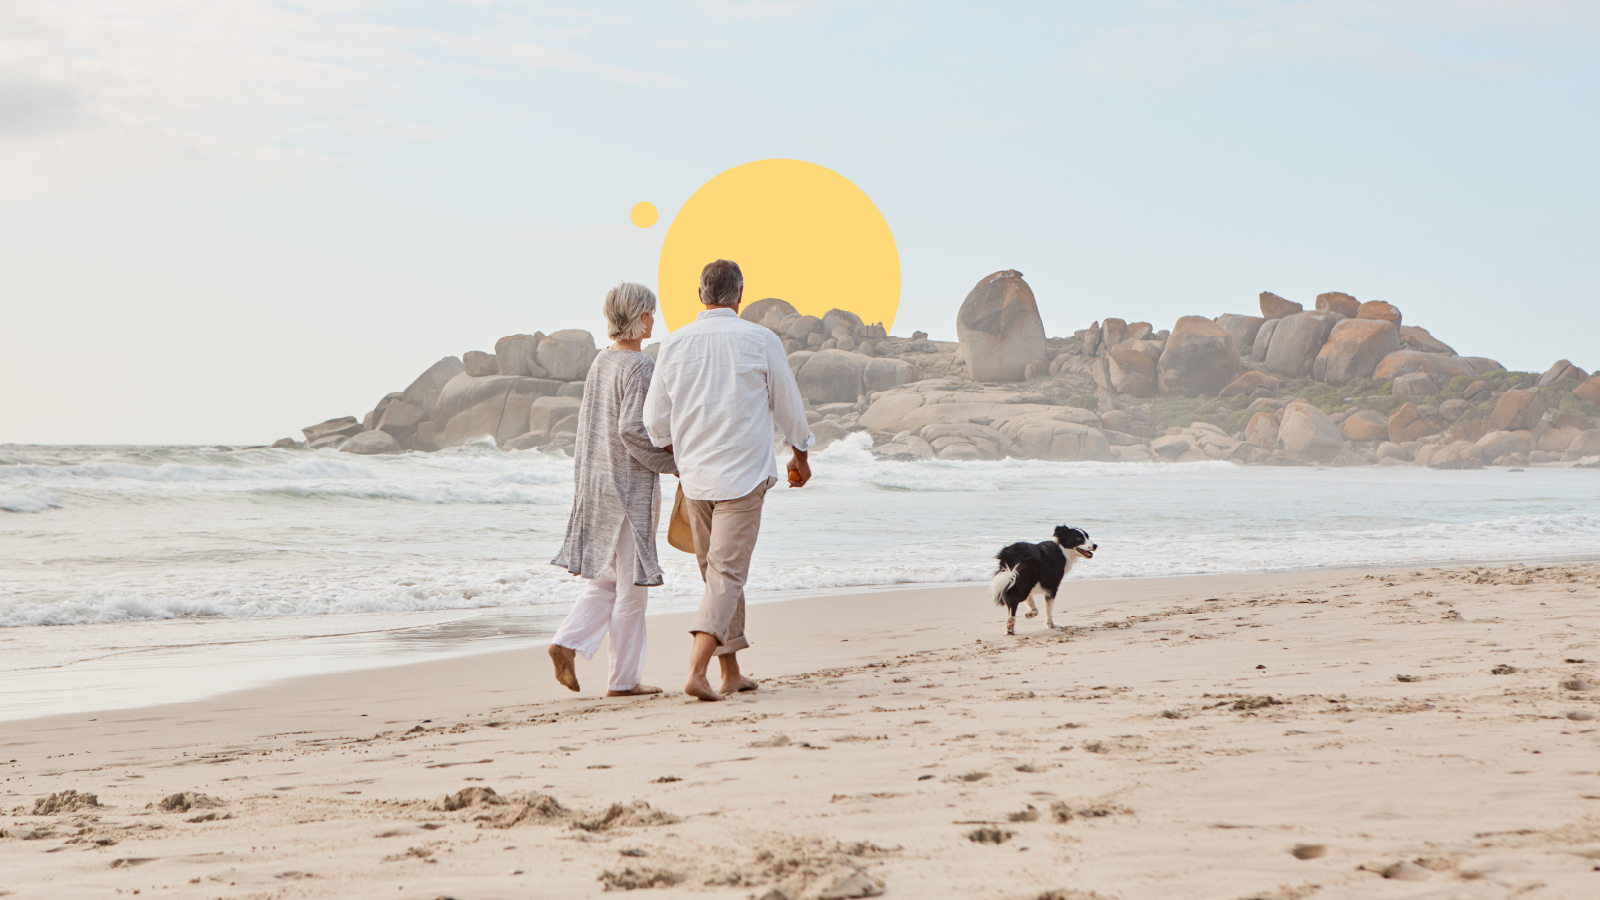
[656,160,901,328]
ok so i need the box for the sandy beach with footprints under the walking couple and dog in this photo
[0,564,1600,900]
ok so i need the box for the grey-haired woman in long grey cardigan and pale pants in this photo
[550,282,678,697]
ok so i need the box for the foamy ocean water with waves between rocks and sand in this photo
[0,436,1600,717]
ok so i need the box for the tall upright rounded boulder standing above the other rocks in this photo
[955,269,1045,381]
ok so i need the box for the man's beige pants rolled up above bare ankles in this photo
[685,479,774,655]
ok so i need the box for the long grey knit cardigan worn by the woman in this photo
[550,348,678,585]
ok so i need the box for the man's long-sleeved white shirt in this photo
[645,301,816,500]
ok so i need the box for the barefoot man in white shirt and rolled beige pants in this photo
[645,259,814,700]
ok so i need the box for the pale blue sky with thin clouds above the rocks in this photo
[0,0,1600,444]
